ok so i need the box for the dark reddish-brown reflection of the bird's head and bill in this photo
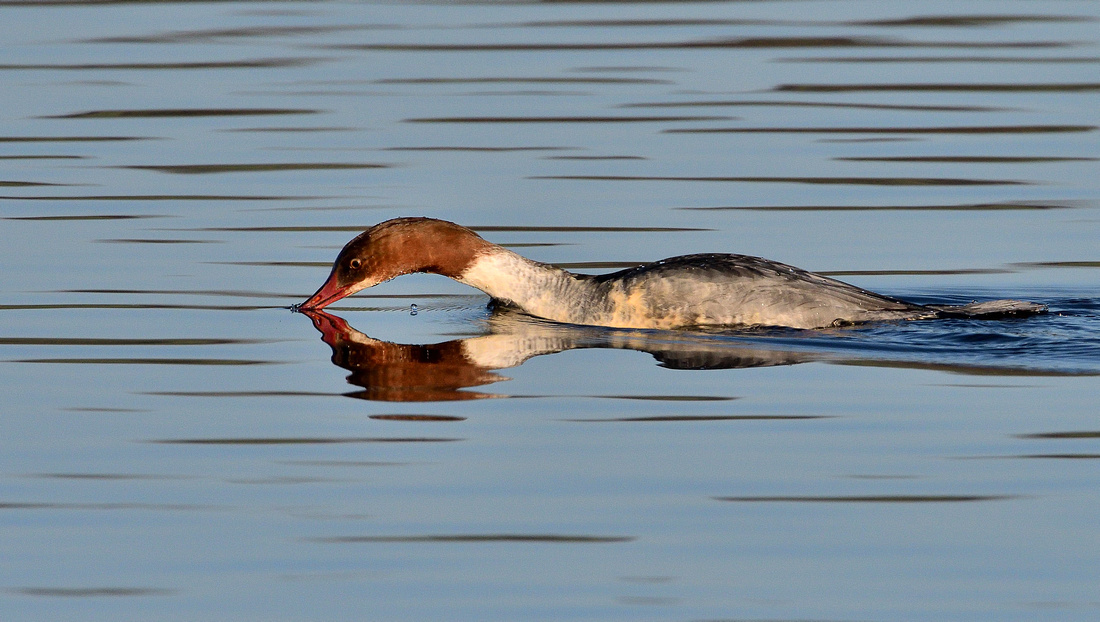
[303,310,504,402]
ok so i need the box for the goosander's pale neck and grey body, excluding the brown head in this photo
[458,252,928,328]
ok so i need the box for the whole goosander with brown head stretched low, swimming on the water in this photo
[294,218,1046,329]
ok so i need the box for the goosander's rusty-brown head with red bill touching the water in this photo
[298,218,492,309]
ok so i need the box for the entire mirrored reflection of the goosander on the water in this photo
[303,308,813,402]
